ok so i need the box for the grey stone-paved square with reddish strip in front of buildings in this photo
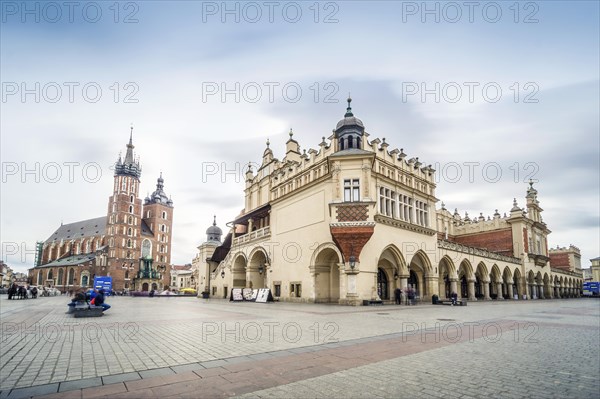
[0,296,600,398]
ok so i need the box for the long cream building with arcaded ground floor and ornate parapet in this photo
[199,99,582,305]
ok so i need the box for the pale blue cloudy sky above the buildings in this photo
[0,1,600,271]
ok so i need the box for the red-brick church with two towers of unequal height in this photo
[29,133,173,292]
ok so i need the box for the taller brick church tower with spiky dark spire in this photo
[101,127,142,291]
